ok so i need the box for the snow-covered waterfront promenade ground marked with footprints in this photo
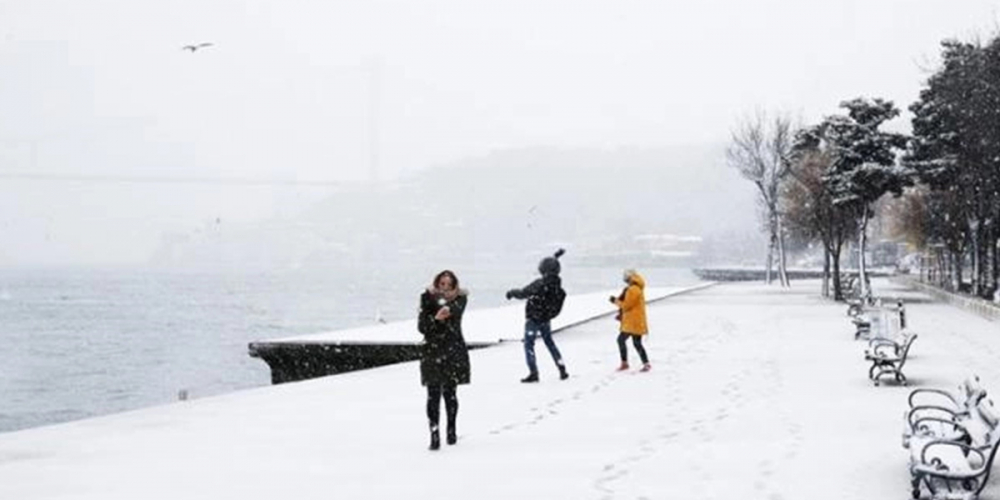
[0,281,1000,500]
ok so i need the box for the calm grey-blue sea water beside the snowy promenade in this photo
[0,259,697,432]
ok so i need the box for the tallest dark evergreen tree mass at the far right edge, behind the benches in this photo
[904,39,1000,294]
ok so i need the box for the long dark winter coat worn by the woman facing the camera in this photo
[417,290,471,385]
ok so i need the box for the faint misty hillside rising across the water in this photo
[148,147,756,266]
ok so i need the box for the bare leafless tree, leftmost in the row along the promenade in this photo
[726,111,793,286]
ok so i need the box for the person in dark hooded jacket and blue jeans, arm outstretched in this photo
[507,248,569,383]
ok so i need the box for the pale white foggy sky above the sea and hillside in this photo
[0,0,996,265]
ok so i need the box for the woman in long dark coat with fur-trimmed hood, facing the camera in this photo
[417,270,471,450]
